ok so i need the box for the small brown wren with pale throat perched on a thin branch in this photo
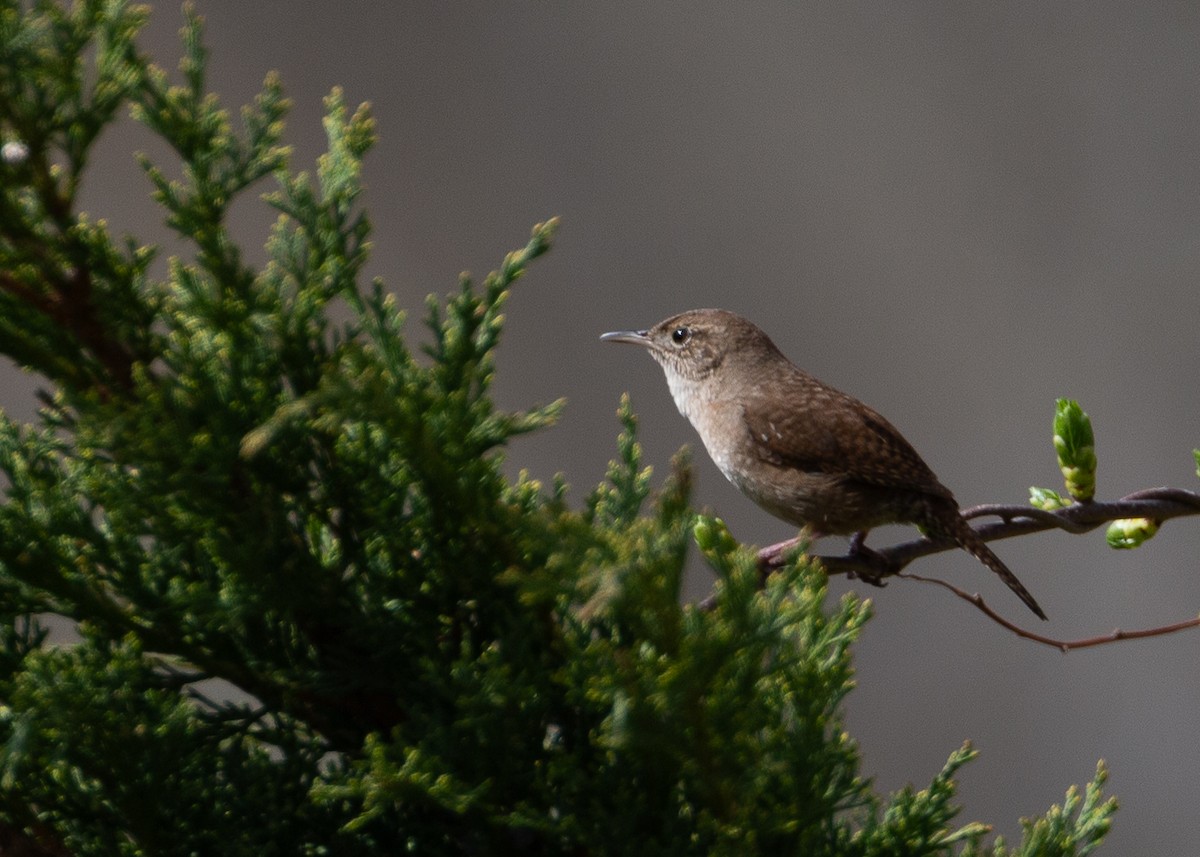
[600,310,1045,619]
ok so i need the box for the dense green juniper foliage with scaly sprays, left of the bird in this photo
[0,0,1114,857]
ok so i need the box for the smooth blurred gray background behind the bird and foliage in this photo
[0,0,1200,855]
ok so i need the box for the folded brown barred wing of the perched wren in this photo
[743,376,953,499]
